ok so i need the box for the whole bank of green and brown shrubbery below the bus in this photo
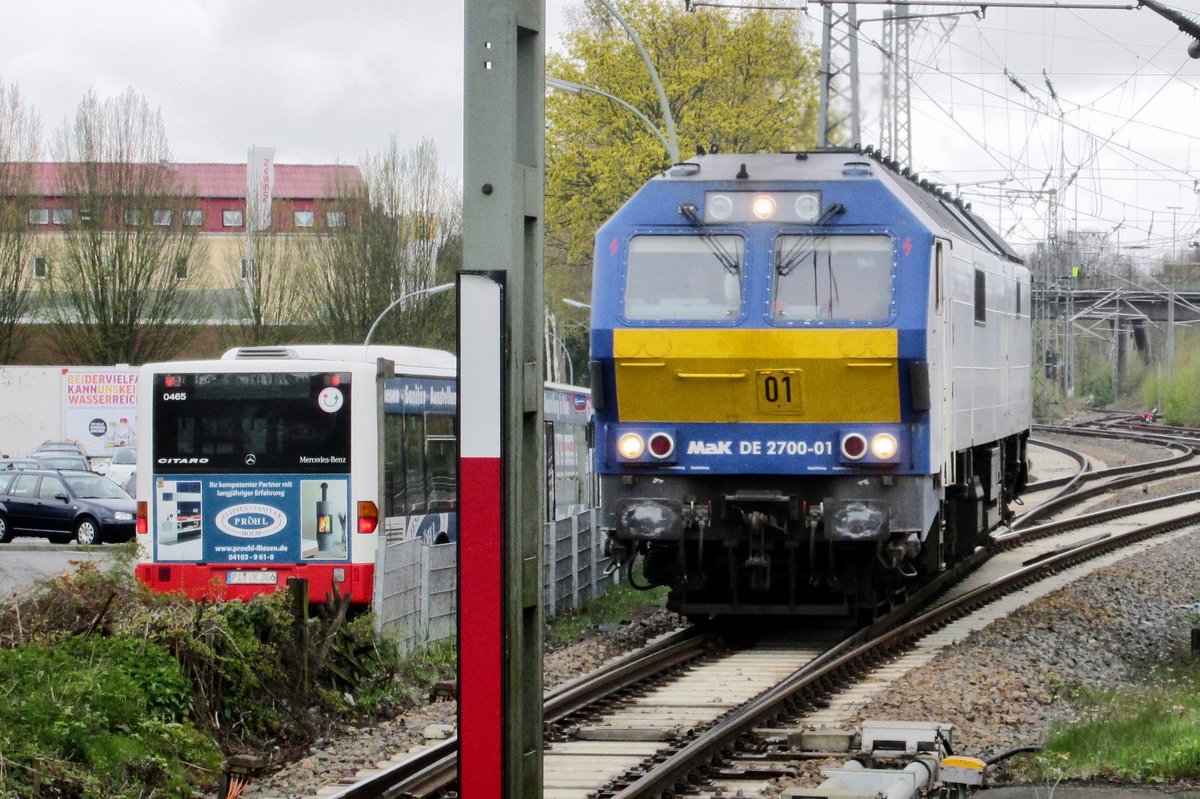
[0,548,454,799]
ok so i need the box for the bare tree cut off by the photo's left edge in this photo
[0,80,42,364]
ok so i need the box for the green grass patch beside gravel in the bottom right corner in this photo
[1022,662,1200,783]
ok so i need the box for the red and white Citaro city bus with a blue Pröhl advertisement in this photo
[136,346,595,605]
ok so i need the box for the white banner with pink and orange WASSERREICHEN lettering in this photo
[62,366,138,456]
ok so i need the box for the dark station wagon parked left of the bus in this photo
[0,469,137,543]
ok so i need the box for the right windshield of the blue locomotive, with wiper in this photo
[772,235,893,322]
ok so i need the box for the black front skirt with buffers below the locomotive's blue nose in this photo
[601,473,943,615]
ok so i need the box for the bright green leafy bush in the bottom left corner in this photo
[0,637,221,799]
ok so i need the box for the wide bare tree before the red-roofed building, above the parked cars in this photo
[46,89,208,364]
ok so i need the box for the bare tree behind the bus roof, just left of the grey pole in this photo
[312,137,462,346]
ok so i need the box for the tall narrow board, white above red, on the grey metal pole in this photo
[458,272,506,799]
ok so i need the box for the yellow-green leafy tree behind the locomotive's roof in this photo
[546,0,820,289]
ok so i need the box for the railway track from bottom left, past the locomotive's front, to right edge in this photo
[292,431,1200,799]
